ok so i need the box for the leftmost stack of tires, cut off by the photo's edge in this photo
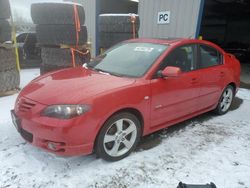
[0,0,20,95]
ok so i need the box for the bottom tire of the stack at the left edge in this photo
[0,69,20,93]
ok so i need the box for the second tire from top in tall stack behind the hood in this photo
[36,25,88,45]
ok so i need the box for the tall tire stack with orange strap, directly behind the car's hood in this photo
[31,3,88,74]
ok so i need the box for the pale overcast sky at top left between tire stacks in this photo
[10,0,63,21]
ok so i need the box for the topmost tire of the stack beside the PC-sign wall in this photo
[99,14,140,33]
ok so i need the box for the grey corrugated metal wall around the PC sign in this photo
[139,0,201,38]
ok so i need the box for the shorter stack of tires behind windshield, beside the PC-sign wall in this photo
[99,14,140,49]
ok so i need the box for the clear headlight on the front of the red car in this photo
[42,105,90,119]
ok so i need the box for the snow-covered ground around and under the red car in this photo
[0,69,250,188]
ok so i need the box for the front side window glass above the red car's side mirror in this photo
[158,45,196,72]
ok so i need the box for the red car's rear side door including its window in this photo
[198,44,225,110]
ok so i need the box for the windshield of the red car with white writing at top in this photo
[88,43,167,77]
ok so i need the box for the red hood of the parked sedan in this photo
[20,68,135,105]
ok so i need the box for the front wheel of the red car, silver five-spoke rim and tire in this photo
[95,112,141,161]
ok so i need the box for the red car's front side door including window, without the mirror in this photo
[151,45,200,126]
